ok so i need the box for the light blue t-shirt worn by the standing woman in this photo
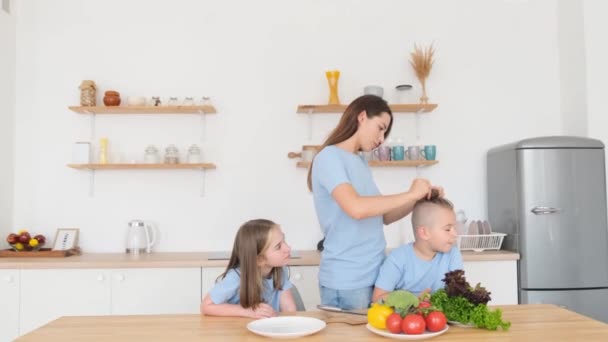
[312,146,386,290]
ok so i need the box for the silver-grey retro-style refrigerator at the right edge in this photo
[487,137,608,322]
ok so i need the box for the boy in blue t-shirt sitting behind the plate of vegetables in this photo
[372,193,463,302]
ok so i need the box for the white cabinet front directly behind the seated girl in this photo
[202,266,321,310]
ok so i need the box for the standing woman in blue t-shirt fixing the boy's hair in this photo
[308,95,443,309]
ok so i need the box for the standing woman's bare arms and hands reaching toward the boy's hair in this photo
[331,178,431,222]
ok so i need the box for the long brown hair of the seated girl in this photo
[218,219,283,309]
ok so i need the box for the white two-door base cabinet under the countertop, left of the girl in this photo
[19,267,201,335]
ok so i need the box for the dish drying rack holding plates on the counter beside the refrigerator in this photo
[458,221,507,252]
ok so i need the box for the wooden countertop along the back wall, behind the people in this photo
[0,250,519,269]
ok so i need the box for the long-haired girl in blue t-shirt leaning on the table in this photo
[201,219,296,318]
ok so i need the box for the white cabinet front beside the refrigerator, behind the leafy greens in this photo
[464,260,517,305]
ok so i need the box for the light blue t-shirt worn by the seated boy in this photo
[376,243,463,295]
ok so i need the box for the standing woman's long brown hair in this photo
[308,95,393,191]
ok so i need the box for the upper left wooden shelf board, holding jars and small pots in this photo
[68,106,216,114]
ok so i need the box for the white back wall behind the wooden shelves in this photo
[14,0,562,251]
